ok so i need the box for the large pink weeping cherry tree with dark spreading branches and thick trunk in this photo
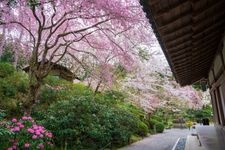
[0,0,151,113]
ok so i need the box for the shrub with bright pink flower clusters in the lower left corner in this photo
[6,116,53,150]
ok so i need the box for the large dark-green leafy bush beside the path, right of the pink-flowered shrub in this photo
[41,96,142,149]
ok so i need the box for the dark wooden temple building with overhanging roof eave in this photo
[140,0,225,150]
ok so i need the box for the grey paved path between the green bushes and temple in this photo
[120,129,194,150]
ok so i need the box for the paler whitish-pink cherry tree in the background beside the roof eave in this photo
[120,45,202,114]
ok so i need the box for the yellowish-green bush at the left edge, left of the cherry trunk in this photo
[0,63,28,117]
